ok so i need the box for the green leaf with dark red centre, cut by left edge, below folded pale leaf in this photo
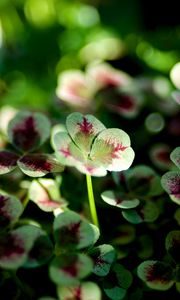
[0,194,23,230]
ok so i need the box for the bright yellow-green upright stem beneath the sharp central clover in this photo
[86,174,99,228]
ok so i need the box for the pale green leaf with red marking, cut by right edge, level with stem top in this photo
[161,171,180,204]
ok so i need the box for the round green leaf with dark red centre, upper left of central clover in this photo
[8,111,50,152]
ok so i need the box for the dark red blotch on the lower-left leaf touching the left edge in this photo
[0,234,24,259]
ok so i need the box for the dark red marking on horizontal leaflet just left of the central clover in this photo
[19,154,52,172]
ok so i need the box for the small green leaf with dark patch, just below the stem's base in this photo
[89,244,116,276]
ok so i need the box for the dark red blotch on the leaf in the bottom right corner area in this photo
[146,263,170,284]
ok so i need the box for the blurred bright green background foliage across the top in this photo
[0,0,180,109]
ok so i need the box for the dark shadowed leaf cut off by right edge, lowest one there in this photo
[165,230,180,263]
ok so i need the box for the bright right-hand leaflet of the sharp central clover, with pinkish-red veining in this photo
[90,128,134,171]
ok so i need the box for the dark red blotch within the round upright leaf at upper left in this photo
[13,116,40,151]
